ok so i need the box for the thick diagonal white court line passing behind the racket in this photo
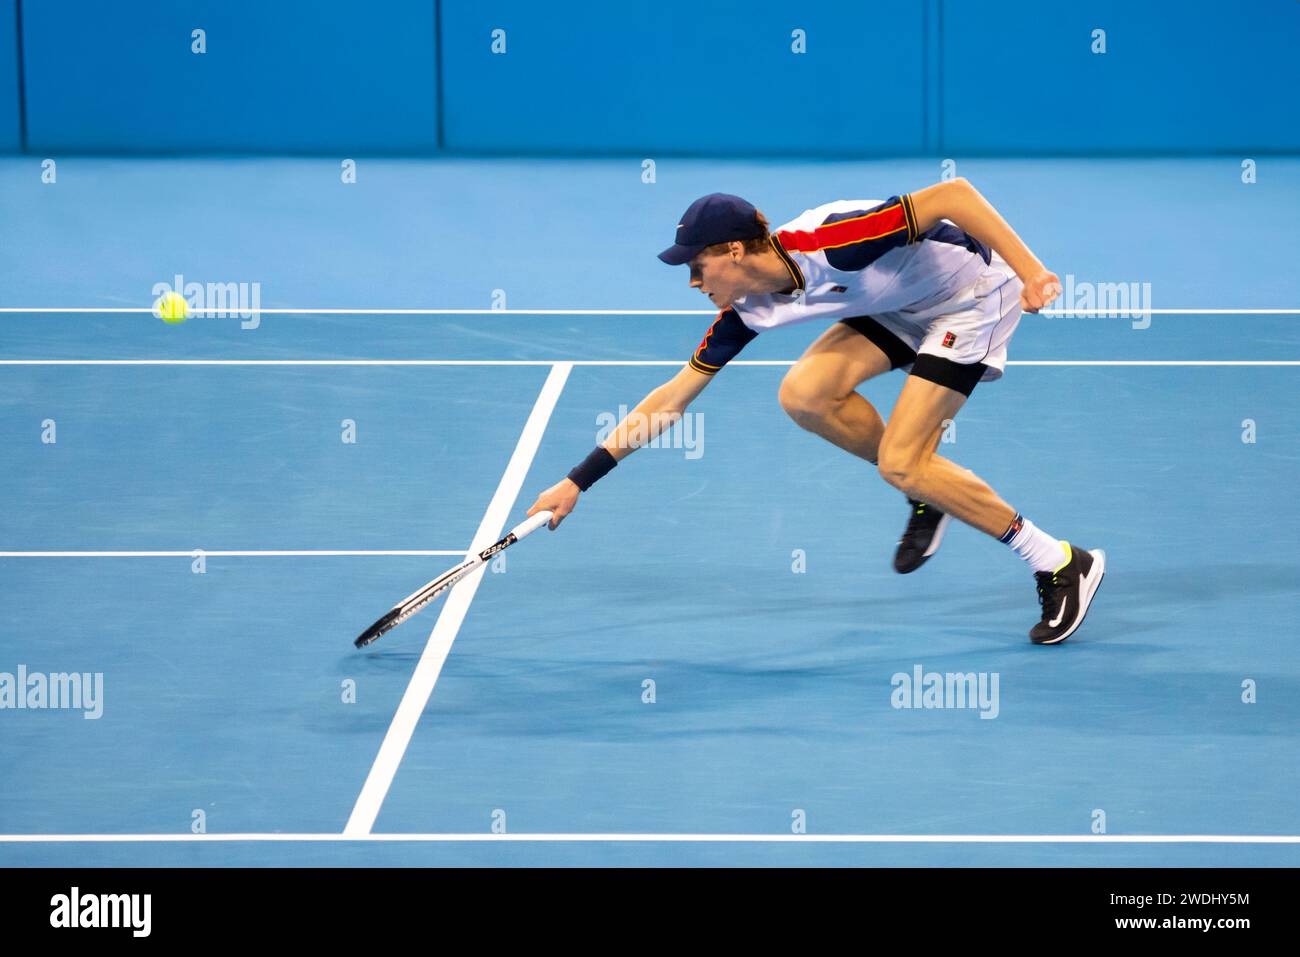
[343,363,572,836]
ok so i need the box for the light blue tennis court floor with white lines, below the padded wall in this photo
[0,159,1300,866]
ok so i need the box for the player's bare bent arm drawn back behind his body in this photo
[911,177,1061,312]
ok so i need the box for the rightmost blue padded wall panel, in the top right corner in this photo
[939,0,1300,155]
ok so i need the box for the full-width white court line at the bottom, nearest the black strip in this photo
[0,831,1300,844]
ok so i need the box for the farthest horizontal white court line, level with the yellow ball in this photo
[0,306,1300,319]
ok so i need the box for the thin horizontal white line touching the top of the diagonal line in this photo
[0,359,1300,368]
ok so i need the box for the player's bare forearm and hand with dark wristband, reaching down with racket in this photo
[528,365,712,528]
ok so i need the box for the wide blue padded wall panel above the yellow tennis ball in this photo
[23,0,437,152]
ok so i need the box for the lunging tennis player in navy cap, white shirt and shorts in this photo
[528,178,1106,645]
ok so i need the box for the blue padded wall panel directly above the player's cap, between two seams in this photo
[442,0,926,156]
